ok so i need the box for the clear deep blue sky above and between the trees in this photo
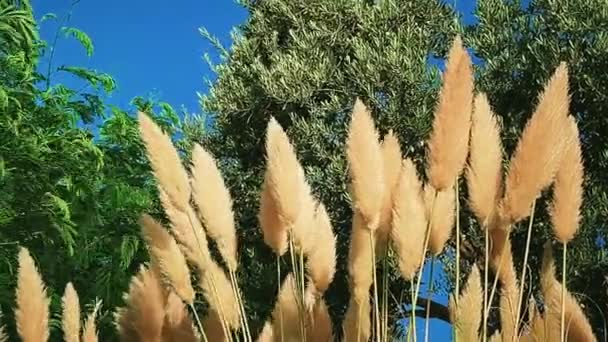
[32,0,475,341]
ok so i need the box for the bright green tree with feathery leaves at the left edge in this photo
[0,0,197,340]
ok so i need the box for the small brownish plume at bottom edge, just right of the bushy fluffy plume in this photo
[162,292,200,342]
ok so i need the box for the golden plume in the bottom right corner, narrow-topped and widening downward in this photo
[540,242,597,341]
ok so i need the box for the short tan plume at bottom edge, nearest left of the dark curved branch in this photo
[342,297,371,342]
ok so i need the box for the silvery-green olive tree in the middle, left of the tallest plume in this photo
[203,0,457,336]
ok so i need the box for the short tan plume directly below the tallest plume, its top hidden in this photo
[424,184,456,256]
